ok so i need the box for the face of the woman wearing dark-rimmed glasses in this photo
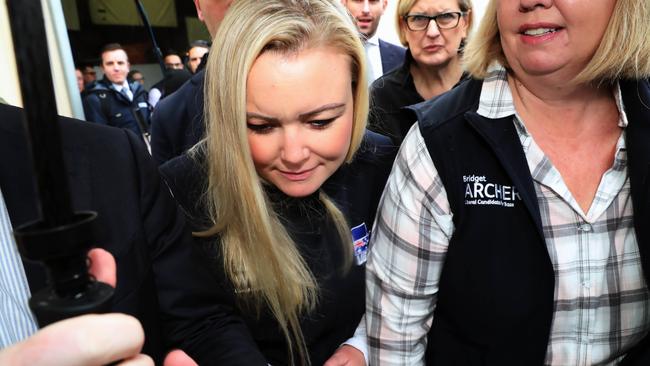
[400,0,467,67]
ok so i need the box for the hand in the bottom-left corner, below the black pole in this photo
[0,314,153,366]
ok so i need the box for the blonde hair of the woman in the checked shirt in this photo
[464,0,650,83]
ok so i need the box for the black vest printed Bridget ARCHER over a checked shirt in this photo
[412,80,650,366]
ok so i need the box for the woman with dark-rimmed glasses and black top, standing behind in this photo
[368,0,472,144]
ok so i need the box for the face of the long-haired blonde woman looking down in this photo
[246,48,354,197]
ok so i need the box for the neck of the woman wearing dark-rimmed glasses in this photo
[410,57,463,100]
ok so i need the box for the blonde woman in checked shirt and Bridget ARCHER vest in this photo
[366,0,650,365]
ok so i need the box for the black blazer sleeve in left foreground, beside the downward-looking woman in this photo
[124,131,266,365]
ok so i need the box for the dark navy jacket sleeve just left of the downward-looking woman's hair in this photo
[151,69,205,165]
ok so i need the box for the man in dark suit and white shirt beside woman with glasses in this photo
[342,0,405,85]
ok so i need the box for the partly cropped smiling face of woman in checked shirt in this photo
[497,0,612,78]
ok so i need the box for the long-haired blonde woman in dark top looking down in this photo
[162,0,394,365]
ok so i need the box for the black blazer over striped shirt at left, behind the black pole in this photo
[0,105,258,363]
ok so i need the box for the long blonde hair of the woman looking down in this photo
[196,0,368,364]
